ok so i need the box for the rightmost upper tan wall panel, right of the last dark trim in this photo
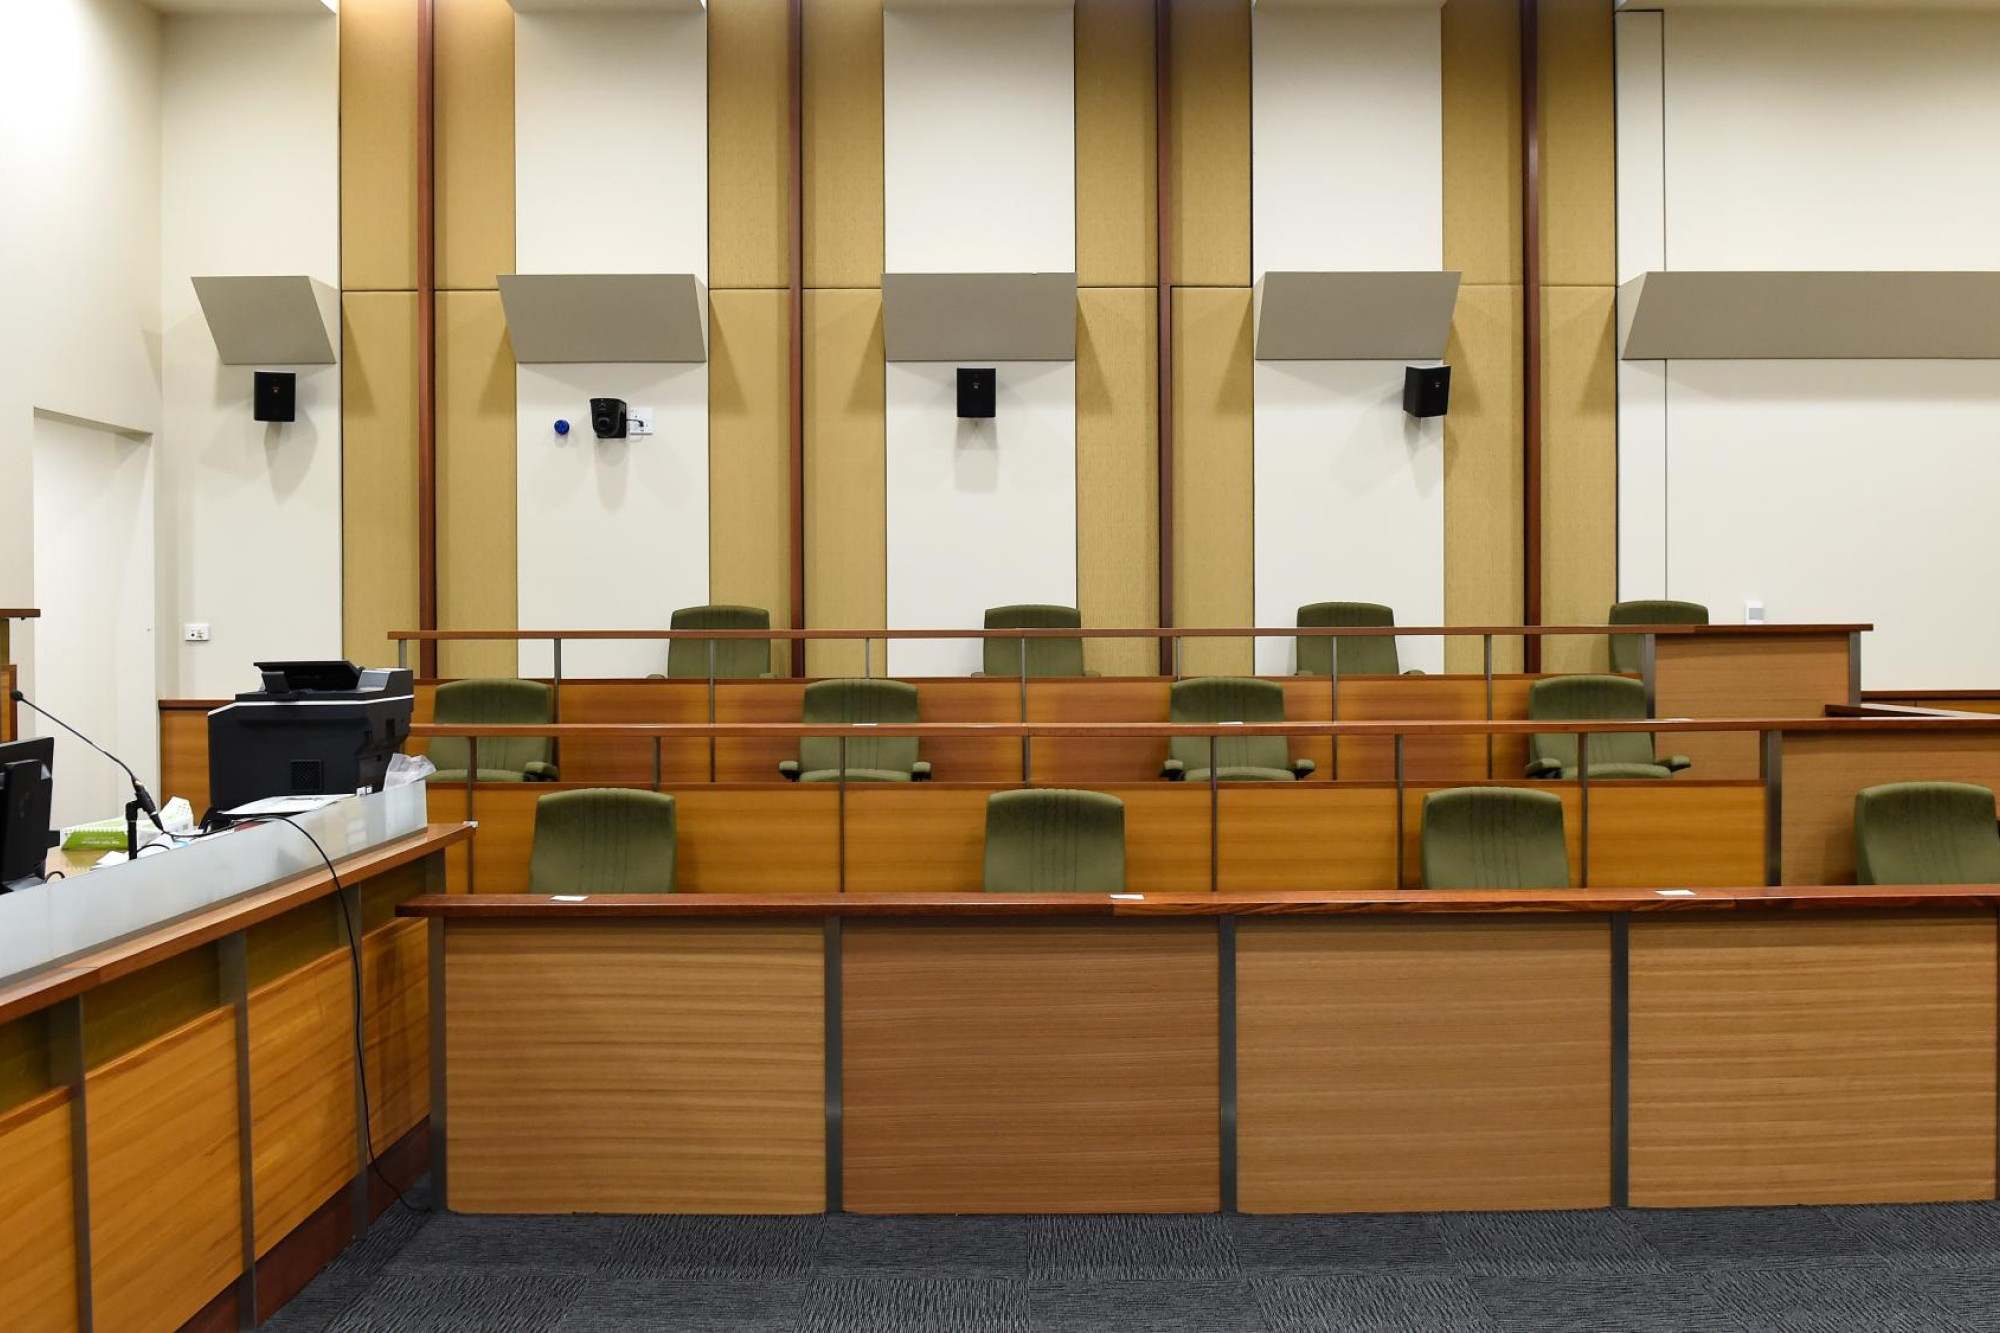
[1536,0,1618,288]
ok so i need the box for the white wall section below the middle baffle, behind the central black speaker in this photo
[888,360,1076,677]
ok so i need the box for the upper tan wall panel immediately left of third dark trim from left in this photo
[1076,0,1160,286]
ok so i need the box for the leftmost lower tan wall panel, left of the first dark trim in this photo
[340,294,418,664]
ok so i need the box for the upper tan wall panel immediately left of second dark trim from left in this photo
[708,0,788,288]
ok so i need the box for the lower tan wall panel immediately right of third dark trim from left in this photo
[1174,286,1256,675]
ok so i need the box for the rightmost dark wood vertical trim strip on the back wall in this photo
[1520,0,1542,671]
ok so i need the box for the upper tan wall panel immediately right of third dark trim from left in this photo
[1170,0,1252,286]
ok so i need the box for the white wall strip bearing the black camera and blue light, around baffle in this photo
[514,14,708,677]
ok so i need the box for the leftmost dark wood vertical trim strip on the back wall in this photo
[416,0,438,679]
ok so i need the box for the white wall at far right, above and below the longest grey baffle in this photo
[1618,10,2000,689]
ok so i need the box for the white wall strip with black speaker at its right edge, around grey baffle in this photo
[1250,4,1444,673]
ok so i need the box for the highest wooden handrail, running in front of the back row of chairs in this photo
[388,624,1874,642]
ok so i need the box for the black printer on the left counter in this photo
[208,662,416,811]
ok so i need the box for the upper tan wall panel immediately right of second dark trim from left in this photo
[804,0,882,286]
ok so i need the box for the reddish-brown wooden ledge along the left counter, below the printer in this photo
[0,825,472,1023]
